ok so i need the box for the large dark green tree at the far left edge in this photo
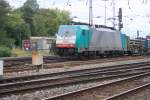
[0,0,30,48]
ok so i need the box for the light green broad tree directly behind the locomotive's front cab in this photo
[33,9,71,36]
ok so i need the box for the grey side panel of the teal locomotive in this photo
[89,28,122,52]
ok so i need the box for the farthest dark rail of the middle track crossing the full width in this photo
[0,62,150,84]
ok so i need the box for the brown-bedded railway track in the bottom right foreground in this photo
[44,72,150,100]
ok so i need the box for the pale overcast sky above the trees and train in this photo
[6,0,150,38]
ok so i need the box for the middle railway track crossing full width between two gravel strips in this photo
[0,63,150,96]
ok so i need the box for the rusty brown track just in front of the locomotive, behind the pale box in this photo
[4,56,150,73]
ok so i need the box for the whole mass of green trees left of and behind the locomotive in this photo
[0,0,71,51]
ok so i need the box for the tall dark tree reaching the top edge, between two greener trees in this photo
[21,0,39,36]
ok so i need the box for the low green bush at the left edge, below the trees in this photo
[0,45,11,57]
